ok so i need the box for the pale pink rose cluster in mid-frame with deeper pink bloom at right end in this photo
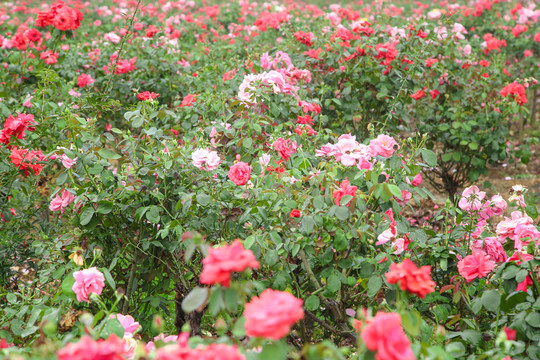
[315,134,399,170]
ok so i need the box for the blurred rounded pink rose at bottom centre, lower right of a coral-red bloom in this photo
[244,289,304,340]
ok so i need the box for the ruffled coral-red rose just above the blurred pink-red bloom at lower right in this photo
[386,259,435,299]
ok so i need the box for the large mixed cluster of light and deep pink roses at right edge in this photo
[458,185,540,291]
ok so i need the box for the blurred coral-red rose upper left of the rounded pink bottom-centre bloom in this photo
[200,239,260,287]
